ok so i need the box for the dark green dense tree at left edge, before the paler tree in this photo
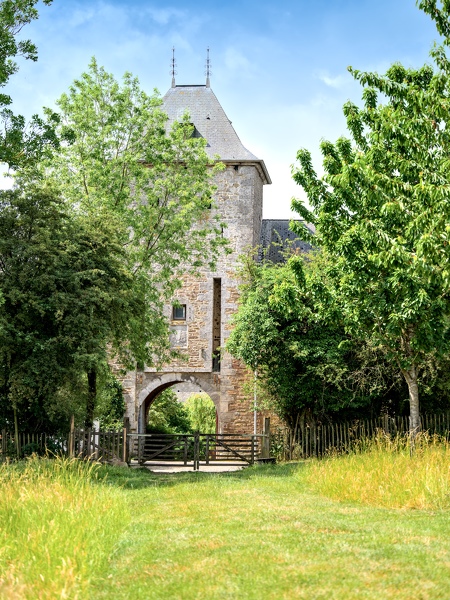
[0,186,134,426]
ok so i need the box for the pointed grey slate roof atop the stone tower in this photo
[163,85,272,183]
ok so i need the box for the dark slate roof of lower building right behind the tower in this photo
[259,219,314,263]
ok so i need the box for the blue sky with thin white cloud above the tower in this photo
[6,0,437,218]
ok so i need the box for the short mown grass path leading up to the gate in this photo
[97,465,450,600]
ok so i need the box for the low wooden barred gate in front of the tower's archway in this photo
[128,433,265,471]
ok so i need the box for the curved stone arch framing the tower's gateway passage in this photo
[138,373,220,433]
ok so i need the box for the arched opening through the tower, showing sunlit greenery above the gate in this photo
[145,382,218,434]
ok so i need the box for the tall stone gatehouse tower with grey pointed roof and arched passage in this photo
[124,77,271,433]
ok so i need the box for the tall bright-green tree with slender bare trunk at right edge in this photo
[293,7,450,431]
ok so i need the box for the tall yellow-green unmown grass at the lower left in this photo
[0,457,127,600]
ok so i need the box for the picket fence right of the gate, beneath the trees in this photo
[270,412,450,460]
